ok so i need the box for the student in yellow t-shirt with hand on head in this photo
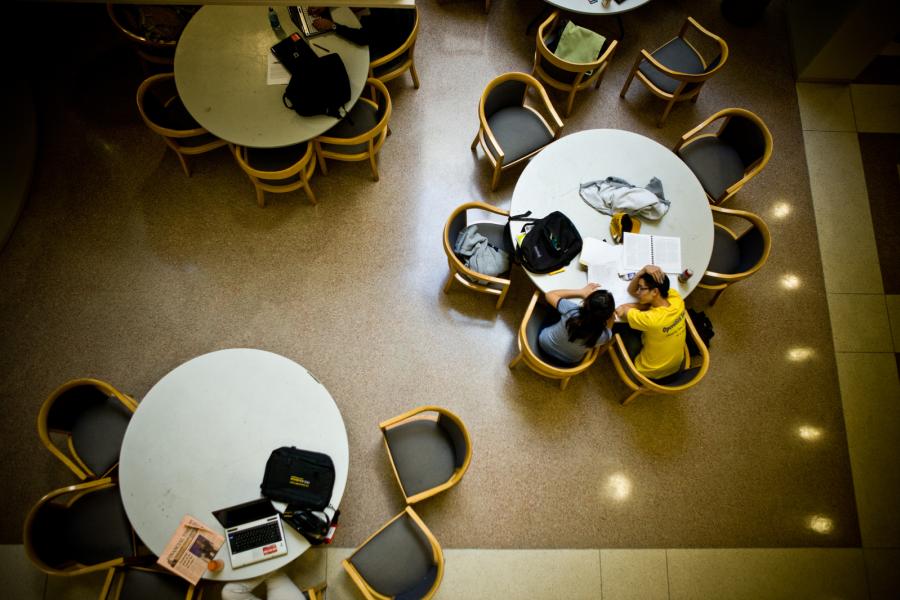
[614,265,686,379]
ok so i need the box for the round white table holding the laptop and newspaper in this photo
[119,348,350,581]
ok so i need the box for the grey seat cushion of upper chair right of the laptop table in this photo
[384,419,456,496]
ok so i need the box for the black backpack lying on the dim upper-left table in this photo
[272,34,350,118]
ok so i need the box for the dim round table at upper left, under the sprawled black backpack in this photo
[175,6,369,148]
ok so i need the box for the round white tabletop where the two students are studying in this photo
[509,129,713,304]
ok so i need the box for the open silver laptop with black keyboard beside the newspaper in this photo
[213,498,287,569]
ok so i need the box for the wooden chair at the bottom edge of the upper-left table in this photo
[231,142,316,208]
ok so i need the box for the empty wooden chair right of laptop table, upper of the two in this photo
[378,406,472,504]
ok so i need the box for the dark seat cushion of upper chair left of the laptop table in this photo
[72,398,131,476]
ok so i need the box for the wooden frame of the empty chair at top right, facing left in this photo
[619,17,728,127]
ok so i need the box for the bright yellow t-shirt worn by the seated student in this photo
[626,289,687,379]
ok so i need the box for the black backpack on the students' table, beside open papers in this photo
[507,210,581,274]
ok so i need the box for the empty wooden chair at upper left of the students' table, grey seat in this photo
[472,73,563,190]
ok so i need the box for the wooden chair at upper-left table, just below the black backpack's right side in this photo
[314,77,391,181]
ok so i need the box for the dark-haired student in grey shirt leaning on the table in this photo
[538,283,616,365]
